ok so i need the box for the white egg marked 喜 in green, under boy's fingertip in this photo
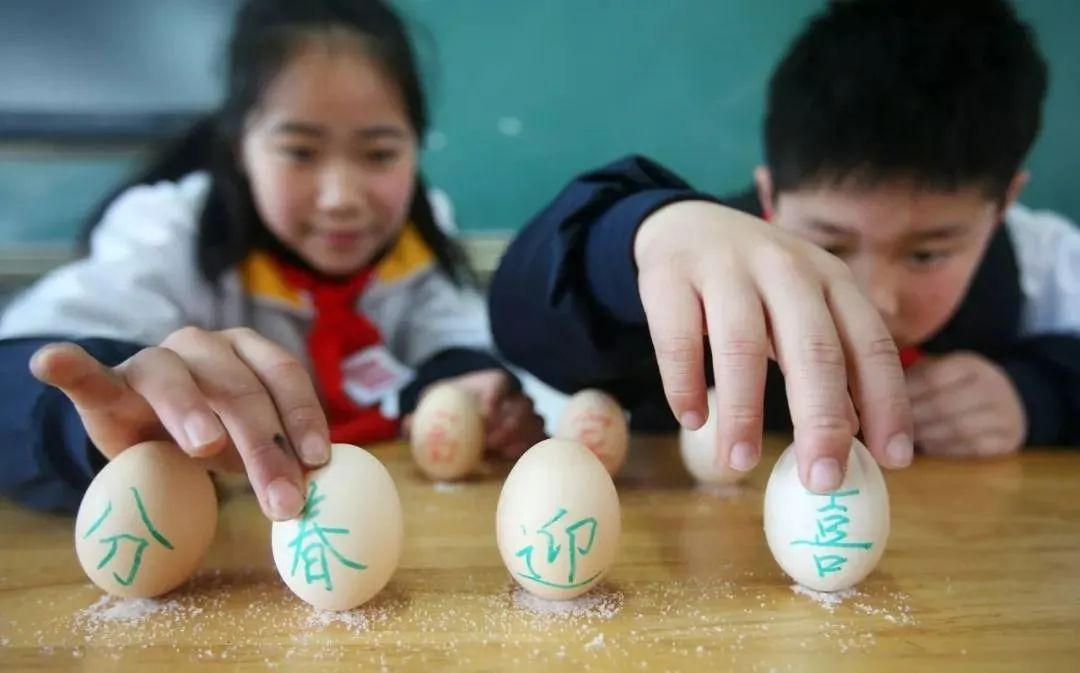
[765,440,889,591]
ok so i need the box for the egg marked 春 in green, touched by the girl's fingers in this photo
[270,444,405,610]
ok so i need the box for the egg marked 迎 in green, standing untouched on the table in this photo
[495,439,622,601]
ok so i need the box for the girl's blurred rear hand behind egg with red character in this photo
[403,369,545,459]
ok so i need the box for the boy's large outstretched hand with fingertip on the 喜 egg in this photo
[634,201,913,492]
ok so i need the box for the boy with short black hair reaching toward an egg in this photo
[490,0,1080,492]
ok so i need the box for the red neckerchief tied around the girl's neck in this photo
[279,264,399,444]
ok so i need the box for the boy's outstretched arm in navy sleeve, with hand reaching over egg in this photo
[491,158,912,493]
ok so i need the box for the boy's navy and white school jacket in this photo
[489,157,1080,446]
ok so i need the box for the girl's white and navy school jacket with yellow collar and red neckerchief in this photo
[0,172,500,510]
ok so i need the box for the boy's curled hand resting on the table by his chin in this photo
[907,352,1027,458]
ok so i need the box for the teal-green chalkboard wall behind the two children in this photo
[0,0,1080,248]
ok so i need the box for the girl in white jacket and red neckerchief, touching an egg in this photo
[0,0,543,520]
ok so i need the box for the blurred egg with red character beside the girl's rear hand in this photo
[409,385,484,482]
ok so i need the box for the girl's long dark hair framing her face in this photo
[80,0,474,284]
